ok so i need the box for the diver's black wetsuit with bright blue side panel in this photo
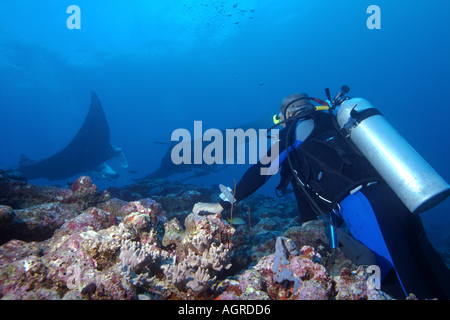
[220,113,450,299]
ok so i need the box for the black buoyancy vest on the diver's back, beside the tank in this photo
[277,112,383,210]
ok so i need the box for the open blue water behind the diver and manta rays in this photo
[0,0,450,243]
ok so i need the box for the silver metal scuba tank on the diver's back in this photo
[337,98,450,213]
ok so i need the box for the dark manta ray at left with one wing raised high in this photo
[16,91,128,180]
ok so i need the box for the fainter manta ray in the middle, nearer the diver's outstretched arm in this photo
[134,115,273,181]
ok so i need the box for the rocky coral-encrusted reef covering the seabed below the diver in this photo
[0,174,391,300]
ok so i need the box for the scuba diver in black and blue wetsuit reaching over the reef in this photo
[193,86,450,299]
